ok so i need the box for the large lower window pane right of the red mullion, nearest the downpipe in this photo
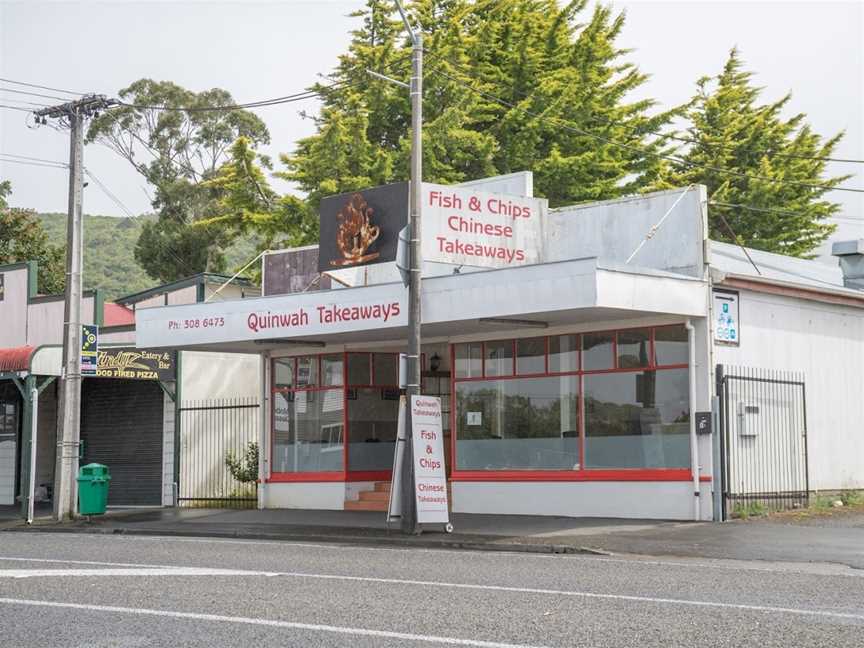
[583,369,690,468]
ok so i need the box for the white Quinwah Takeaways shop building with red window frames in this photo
[136,174,864,520]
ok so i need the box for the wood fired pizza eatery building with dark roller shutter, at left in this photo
[0,262,260,506]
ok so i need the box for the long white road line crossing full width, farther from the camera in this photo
[0,558,864,621]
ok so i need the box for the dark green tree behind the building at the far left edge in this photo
[0,180,66,294]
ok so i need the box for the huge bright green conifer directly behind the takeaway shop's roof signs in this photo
[228,0,676,244]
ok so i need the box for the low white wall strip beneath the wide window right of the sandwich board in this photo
[452,481,711,520]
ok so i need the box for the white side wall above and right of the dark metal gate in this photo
[714,290,864,490]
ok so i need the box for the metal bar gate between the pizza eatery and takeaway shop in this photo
[177,398,260,508]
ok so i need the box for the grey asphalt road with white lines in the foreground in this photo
[0,533,864,648]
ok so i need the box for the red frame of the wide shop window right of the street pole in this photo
[450,324,693,482]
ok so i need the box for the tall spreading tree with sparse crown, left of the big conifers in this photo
[87,79,270,281]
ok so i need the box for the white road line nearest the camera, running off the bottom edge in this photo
[0,598,544,648]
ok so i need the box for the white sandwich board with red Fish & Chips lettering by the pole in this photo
[411,396,450,524]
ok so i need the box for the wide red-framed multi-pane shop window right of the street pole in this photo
[453,325,690,478]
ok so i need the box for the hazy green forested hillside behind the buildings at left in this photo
[39,214,256,299]
